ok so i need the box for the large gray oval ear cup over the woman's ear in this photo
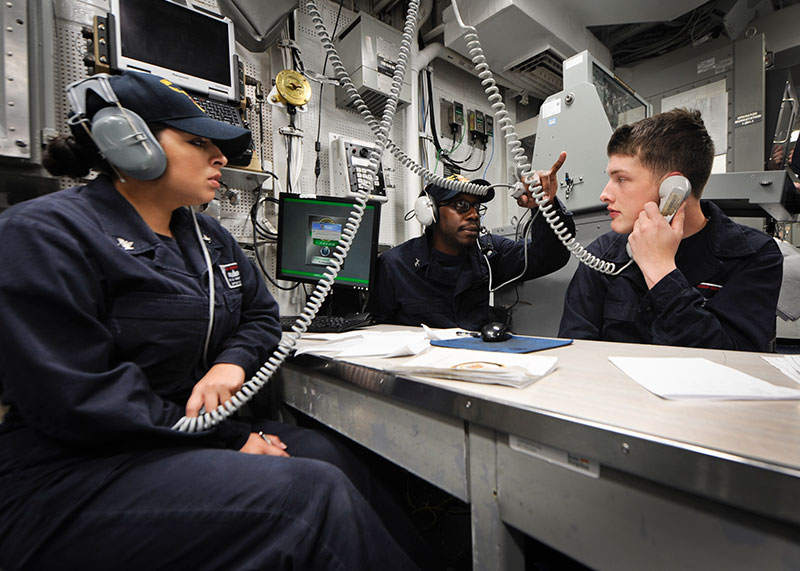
[91,106,167,180]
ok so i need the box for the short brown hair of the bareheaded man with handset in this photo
[606,108,714,198]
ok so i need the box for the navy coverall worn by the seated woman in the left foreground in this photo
[0,177,414,571]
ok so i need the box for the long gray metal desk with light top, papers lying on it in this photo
[277,330,800,570]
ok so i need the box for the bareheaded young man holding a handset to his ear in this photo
[559,105,783,351]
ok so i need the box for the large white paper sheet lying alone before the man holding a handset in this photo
[608,357,800,400]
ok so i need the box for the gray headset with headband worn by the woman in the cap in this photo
[67,73,167,180]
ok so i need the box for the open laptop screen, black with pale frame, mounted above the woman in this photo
[109,0,238,101]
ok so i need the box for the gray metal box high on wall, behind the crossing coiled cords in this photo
[334,13,411,116]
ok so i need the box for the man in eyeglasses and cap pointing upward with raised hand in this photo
[370,165,575,331]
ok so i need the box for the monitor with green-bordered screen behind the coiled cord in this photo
[276,192,380,289]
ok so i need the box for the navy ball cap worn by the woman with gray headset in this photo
[86,71,250,161]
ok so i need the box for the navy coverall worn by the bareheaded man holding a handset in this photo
[559,201,783,351]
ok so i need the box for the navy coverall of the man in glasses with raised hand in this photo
[370,206,575,330]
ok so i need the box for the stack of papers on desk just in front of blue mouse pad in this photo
[389,347,558,388]
